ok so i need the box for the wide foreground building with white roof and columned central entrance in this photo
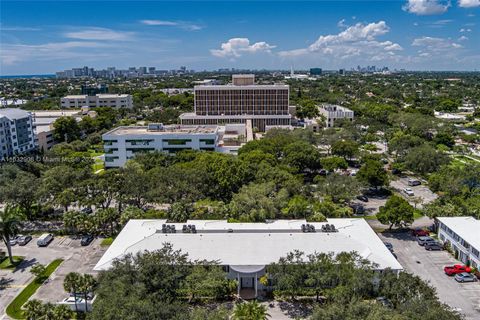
[94,219,403,296]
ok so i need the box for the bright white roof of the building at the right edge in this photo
[437,217,480,250]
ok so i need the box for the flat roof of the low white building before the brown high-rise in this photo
[105,125,218,136]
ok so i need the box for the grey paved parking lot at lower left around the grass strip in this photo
[0,237,106,319]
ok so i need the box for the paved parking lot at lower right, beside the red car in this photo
[379,233,480,320]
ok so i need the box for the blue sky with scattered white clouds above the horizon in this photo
[0,0,480,75]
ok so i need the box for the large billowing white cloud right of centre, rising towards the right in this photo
[279,21,403,60]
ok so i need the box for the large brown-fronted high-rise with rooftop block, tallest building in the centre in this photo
[180,75,291,131]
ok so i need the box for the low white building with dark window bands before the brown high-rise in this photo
[102,124,247,168]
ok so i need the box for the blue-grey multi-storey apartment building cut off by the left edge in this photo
[0,108,36,159]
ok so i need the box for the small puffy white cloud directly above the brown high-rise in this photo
[210,38,276,58]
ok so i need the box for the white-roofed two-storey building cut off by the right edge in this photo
[436,217,480,268]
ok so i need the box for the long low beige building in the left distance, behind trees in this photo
[61,93,133,109]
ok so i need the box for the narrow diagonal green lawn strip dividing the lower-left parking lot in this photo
[6,259,63,319]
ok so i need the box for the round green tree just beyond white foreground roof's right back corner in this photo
[377,195,414,229]
